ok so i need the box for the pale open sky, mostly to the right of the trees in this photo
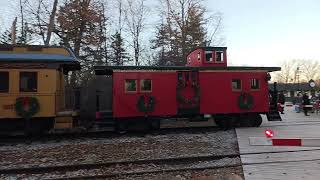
[0,0,320,66]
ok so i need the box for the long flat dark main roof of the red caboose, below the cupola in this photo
[94,66,281,75]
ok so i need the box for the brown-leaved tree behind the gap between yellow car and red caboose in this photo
[55,0,106,86]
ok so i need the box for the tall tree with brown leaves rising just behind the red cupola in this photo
[151,0,220,66]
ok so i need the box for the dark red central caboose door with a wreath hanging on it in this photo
[177,71,200,115]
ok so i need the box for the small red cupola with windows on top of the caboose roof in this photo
[186,47,227,67]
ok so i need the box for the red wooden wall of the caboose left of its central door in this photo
[113,71,177,118]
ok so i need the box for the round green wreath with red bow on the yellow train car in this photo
[15,97,40,118]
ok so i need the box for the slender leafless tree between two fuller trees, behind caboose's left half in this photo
[124,0,148,66]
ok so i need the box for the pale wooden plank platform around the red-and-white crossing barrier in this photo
[236,107,320,180]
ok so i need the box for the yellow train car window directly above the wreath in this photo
[20,72,38,92]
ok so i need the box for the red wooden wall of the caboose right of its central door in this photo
[199,72,269,114]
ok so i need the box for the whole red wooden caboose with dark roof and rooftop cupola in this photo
[95,47,280,130]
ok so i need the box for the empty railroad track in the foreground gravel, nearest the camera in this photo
[0,154,241,179]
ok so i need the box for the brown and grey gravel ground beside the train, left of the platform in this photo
[0,130,242,179]
